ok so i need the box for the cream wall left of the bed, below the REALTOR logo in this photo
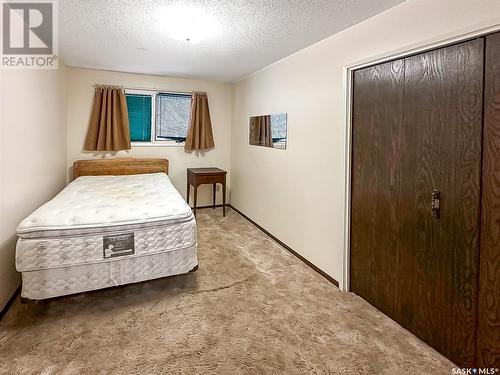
[0,68,66,310]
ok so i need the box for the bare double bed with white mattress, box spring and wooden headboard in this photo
[16,158,198,300]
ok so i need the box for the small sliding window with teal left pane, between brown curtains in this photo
[126,90,191,145]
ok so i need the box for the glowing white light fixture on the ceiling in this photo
[160,4,217,42]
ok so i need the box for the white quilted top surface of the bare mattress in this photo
[17,173,192,238]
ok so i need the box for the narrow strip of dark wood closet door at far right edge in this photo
[477,34,500,367]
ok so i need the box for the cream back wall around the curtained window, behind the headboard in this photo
[66,68,232,205]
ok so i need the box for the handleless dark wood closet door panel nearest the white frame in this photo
[351,60,405,316]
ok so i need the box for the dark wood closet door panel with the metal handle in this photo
[397,39,483,366]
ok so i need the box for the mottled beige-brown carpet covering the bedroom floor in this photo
[0,209,454,374]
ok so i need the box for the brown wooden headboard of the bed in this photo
[73,158,168,179]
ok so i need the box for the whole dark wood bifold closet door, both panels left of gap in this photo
[351,39,483,366]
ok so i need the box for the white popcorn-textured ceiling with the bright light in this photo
[59,0,403,81]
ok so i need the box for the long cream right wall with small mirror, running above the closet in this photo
[231,0,500,290]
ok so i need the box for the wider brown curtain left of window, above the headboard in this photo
[83,86,130,151]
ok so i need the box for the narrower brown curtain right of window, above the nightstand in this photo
[184,92,215,150]
